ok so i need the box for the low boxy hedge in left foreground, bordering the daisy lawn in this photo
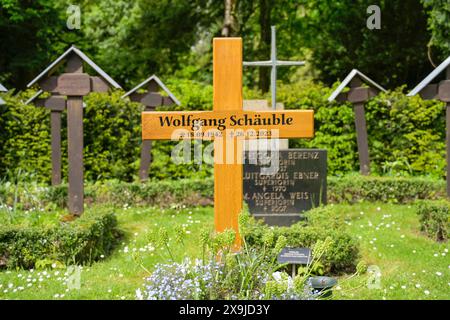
[0,212,121,268]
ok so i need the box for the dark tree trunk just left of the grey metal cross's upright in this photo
[258,0,272,92]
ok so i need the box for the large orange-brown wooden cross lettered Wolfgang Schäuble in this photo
[142,38,314,247]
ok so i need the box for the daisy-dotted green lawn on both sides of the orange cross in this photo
[0,203,450,299]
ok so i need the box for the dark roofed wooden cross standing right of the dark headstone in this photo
[328,69,386,175]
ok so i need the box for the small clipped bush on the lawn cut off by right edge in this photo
[416,200,450,241]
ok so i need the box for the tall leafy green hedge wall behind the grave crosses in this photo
[0,79,445,183]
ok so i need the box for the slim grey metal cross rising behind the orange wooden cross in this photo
[244,26,305,110]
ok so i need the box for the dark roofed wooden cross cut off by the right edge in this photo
[408,57,450,197]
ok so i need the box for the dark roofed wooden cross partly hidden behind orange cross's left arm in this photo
[122,75,180,181]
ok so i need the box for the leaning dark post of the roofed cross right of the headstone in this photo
[354,102,370,176]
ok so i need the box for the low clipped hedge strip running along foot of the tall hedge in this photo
[0,174,446,210]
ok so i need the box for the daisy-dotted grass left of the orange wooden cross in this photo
[0,208,213,299]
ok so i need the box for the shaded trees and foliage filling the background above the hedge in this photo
[0,0,450,92]
